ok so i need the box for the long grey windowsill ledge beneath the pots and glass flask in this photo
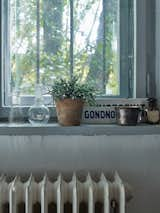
[0,123,160,136]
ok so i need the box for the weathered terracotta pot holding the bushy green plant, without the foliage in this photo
[56,98,84,126]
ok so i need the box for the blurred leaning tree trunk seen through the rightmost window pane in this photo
[87,0,118,94]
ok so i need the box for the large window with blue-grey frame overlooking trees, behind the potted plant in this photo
[1,0,134,105]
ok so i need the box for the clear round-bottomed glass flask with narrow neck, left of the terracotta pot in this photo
[28,84,50,125]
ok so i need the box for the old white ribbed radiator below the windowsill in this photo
[0,173,130,213]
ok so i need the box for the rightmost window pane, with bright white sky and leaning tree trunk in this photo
[74,0,119,95]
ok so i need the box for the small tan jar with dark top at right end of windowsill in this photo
[147,98,160,124]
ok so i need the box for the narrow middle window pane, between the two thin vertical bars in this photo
[40,0,70,84]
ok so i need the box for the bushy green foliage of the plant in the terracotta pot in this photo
[49,76,95,105]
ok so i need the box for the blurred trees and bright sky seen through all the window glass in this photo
[8,0,119,100]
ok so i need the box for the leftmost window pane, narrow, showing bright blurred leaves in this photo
[9,0,36,94]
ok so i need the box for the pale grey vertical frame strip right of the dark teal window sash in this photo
[134,0,147,98]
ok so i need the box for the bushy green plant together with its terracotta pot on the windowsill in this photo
[49,76,95,126]
